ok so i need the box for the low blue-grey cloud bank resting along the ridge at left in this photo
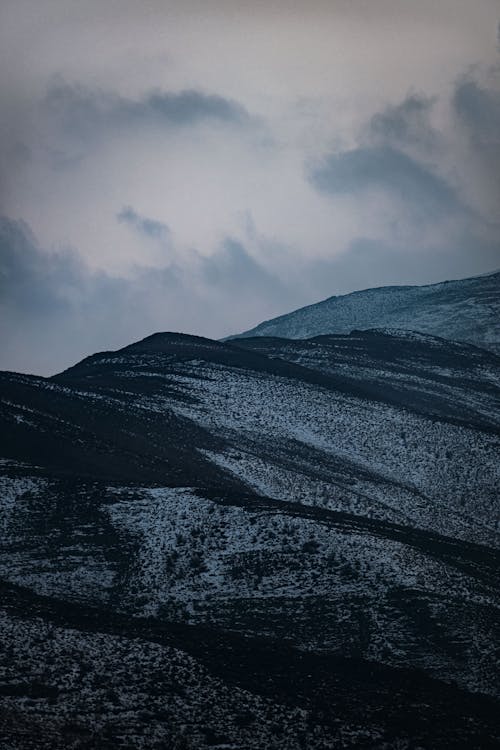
[0,217,297,374]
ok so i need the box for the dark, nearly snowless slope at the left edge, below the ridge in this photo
[0,373,234,484]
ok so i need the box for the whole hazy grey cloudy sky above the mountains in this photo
[0,0,500,374]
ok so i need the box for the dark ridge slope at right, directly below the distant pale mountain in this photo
[232,330,500,430]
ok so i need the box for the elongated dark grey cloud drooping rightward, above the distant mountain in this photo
[310,146,460,217]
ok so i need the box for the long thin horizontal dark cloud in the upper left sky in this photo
[43,80,252,143]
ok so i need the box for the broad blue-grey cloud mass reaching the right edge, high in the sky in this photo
[309,68,500,229]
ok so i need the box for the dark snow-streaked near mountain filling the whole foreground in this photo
[0,331,500,750]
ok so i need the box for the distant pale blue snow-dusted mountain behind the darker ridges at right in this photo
[232,271,500,353]
